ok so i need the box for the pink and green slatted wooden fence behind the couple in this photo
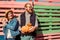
[0,1,60,40]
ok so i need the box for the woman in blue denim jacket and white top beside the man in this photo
[3,10,19,40]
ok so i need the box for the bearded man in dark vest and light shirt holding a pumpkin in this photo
[18,3,38,40]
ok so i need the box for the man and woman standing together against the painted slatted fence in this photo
[3,3,38,40]
